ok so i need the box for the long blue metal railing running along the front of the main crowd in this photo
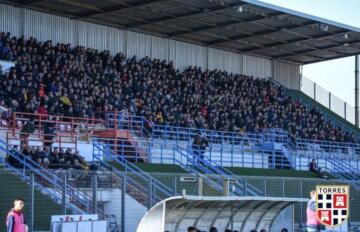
[106,113,360,166]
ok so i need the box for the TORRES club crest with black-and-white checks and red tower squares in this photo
[316,185,350,227]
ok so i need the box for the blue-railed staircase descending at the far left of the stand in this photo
[0,140,103,217]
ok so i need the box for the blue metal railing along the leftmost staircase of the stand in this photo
[0,140,90,213]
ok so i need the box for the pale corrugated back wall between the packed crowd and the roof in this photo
[0,4,300,89]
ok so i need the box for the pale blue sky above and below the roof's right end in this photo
[261,0,360,105]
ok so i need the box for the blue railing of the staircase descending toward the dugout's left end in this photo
[93,138,177,205]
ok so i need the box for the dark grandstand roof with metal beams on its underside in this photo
[4,0,360,64]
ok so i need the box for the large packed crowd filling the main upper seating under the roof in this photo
[0,32,355,142]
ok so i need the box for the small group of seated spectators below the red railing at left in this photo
[8,145,89,170]
